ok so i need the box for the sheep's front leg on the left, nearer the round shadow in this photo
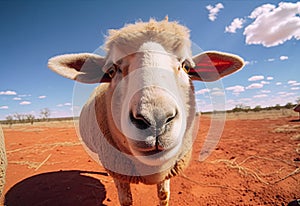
[114,179,132,206]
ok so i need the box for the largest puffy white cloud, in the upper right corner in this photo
[244,2,300,47]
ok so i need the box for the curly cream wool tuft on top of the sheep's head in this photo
[105,18,191,60]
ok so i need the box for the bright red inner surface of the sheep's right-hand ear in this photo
[194,57,234,74]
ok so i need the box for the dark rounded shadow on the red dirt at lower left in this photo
[4,170,107,206]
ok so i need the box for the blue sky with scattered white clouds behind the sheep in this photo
[0,0,300,119]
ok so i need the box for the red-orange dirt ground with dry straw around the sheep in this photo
[2,113,300,206]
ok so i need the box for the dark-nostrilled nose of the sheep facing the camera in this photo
[130,105,178,130]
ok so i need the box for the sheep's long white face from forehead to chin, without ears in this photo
[107,42,195,165]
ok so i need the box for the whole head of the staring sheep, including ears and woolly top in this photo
[49,20,243,165]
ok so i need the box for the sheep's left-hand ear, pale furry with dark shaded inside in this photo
[48,53,111,84]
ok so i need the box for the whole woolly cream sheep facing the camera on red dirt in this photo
[48,18,244,205]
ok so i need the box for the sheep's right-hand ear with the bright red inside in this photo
[189,51,244,82]
